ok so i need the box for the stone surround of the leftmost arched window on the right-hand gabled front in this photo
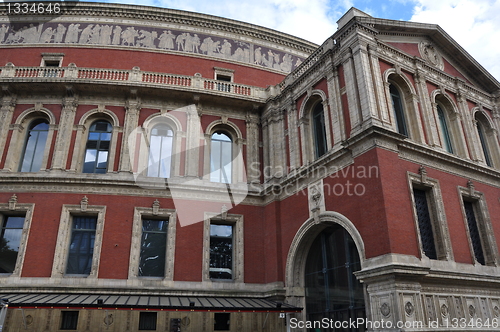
[384,68,425,143]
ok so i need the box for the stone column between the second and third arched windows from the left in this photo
[121,90,141,172]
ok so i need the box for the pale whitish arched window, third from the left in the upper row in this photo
[148,124,174,178]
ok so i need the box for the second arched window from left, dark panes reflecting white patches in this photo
[83,120,112,173]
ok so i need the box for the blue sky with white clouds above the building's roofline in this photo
[82,0,500,80]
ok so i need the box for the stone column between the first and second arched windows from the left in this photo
[51,96,78,170]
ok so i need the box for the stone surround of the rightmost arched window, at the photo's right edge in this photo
[472,108,500,168]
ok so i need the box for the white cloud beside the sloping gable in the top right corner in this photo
[411,0,500,80]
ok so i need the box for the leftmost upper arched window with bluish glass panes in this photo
[20,120,49,172]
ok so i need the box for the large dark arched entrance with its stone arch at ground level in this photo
[286,211,366,332]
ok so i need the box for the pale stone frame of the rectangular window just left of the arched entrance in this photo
[202,212,245,283]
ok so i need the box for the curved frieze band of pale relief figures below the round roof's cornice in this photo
[0,23,302,73]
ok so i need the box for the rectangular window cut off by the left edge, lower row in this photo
[0,216,24,273]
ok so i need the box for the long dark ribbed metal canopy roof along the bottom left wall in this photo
[0,293,302,312]
